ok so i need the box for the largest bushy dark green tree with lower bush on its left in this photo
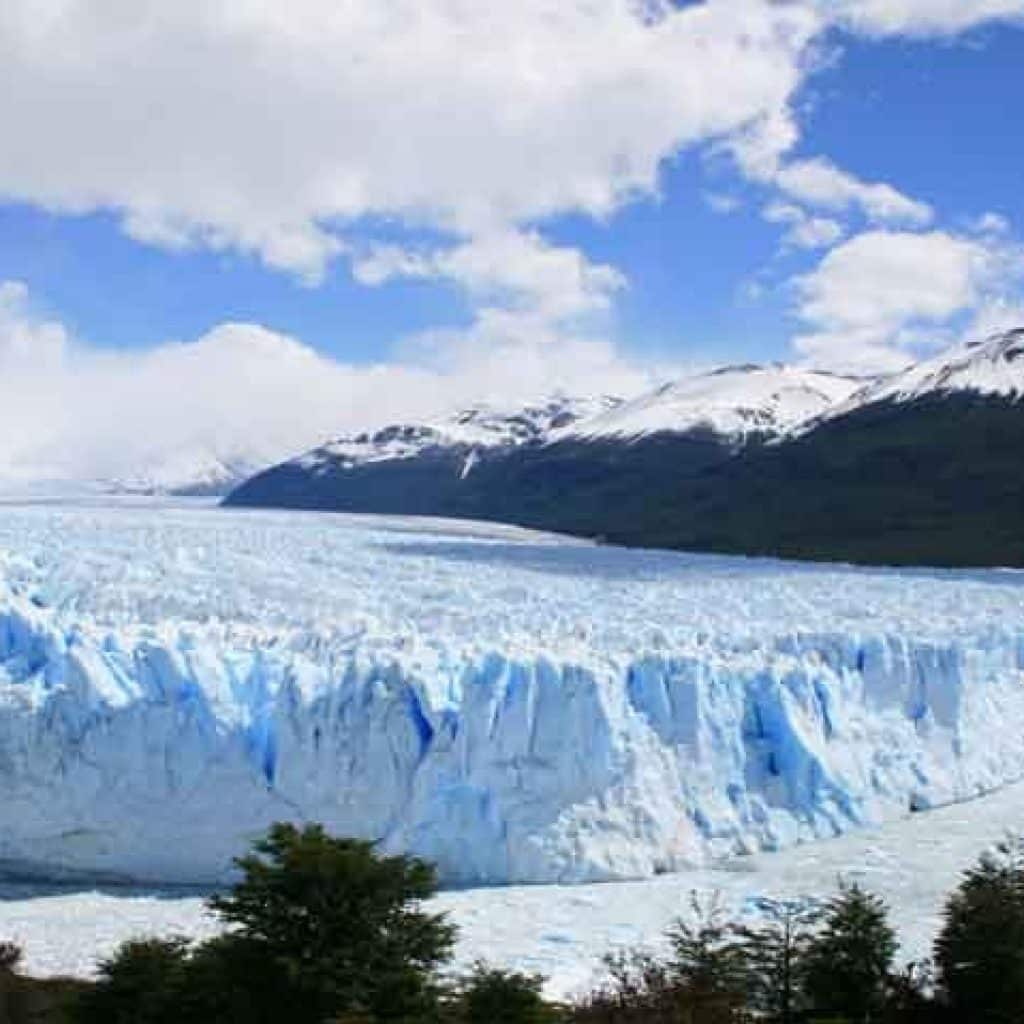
[72,824,454,1024]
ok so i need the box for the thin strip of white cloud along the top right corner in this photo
[818,0,1024,36]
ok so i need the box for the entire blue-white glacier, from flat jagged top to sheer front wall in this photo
[0,501,1024,884]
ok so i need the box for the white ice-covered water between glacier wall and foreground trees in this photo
[6,784,1024,997]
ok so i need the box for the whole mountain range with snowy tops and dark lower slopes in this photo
[226,330,1024,565]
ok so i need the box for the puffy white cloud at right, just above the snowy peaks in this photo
[795,231,1024,371]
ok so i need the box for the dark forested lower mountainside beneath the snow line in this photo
[228,393,1024,565]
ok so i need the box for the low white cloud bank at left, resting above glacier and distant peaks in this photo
[0,283,648,479]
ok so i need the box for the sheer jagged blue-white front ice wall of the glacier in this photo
[0,590,1024,883]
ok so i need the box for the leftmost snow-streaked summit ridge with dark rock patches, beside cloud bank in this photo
[297,394,622,472]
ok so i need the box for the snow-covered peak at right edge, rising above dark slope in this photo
[834,328,1024,415]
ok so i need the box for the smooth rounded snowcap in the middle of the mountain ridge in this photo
[554,364,862,440]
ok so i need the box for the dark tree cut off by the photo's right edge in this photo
[935,840,1024,1024]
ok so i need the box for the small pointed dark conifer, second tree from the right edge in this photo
[803,885,897,1024]
